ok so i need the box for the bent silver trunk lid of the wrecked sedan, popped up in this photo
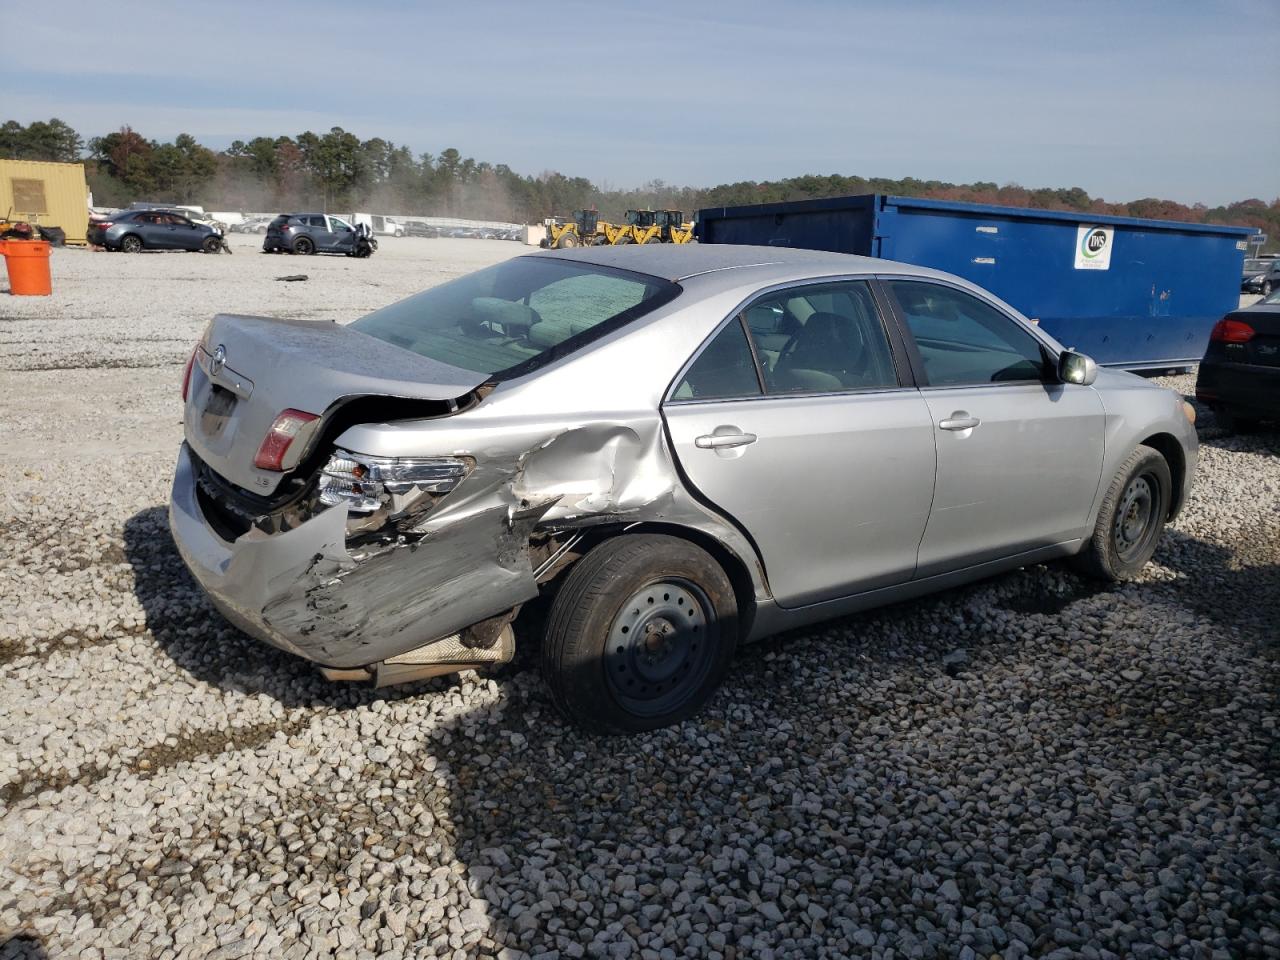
[184,314,485,497]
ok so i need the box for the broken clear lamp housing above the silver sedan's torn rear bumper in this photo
[320,449,475,529]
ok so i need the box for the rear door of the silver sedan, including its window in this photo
[663,280,934,607]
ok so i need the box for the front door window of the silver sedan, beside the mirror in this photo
[887,280,1048,387]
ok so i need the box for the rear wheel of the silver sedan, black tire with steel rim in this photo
[541,534,739,733]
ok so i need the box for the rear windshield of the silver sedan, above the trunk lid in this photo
[352,256,680,379]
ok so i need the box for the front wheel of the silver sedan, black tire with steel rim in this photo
[1073,447,1174,582]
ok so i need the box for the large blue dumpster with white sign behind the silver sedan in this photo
[698,193,1257,370]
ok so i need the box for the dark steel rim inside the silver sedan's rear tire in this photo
[604,577,718,717]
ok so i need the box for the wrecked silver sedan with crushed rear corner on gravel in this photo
[170,244,1197,731]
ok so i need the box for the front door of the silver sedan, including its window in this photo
[884,278,1105,577]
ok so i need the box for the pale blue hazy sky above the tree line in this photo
[0,0,1280,205]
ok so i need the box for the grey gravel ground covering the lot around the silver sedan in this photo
[0,237,1280,960]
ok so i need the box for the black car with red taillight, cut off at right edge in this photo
[1196,289,1280,431]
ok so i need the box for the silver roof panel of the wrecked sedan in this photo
[526,243,945,282]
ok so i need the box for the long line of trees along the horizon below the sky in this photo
[0,118,1280,250]
